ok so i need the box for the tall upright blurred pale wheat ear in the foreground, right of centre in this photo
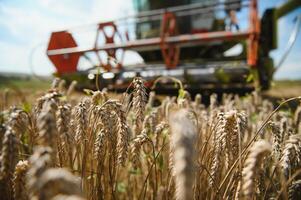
[169,110,196,200]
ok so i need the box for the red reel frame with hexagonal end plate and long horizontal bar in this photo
[47,0,260,74]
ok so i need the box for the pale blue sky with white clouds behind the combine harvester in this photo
[0,0,301,79]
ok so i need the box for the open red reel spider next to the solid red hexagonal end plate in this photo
[95,22,124,71]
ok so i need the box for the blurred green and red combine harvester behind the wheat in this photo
[47,0,301,93]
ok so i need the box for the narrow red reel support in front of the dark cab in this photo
[160,12,180,69]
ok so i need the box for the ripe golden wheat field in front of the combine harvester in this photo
[0,78,301,200]
